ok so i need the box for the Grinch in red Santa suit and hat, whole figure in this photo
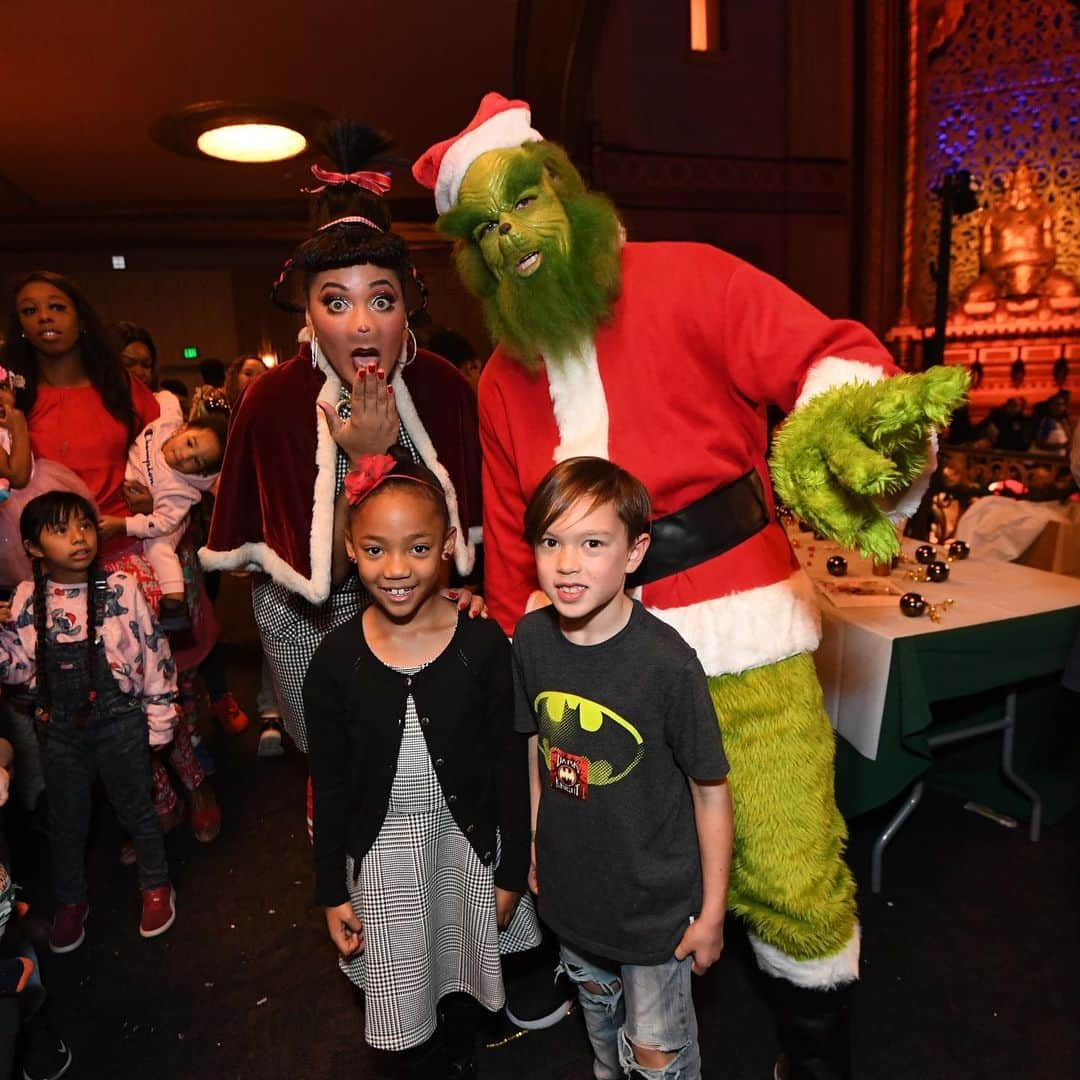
[414,94,966,1078]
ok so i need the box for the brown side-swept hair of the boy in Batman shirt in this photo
[525,457,652,548]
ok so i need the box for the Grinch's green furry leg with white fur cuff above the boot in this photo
[708,653,859,987]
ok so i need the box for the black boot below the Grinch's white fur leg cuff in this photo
[766,978,855,1080]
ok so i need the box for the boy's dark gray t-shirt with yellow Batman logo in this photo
[514,603,728,964]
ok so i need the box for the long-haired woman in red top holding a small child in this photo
[4,270,221,840]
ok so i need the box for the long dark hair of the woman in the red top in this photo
[3,270,137,443]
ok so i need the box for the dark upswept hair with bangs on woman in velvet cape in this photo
[271,120,428,312]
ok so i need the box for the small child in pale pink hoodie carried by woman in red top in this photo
[99,413,229,633]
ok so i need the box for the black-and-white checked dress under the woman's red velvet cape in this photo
[252,408,420,754]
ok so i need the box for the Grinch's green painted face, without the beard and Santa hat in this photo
[458,150,570,282]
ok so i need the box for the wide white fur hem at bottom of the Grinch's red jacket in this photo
[649,570,821,677]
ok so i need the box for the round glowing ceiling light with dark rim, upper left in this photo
[150,98,330,164]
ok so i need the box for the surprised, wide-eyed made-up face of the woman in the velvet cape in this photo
[308,265,406,383]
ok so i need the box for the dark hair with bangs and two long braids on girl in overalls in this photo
[18,491,106,727]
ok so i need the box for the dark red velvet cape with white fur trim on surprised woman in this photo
[199,346,481,604]
